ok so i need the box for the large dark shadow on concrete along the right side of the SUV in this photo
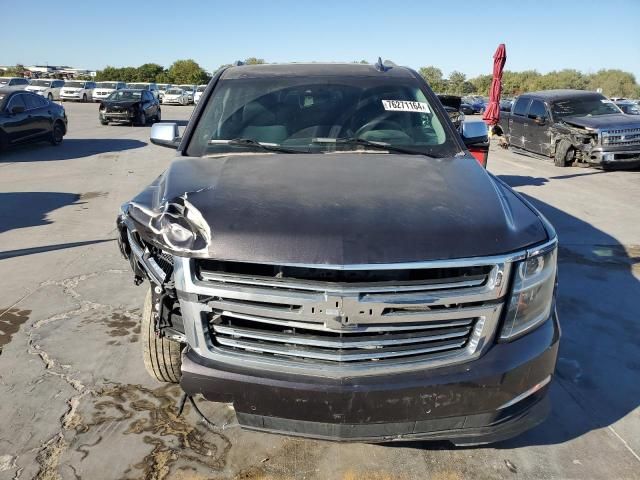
[397,175,640,450]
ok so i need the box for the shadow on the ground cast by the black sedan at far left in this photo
[0,138,146,163]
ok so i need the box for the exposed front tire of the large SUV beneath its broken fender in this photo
[141,288,182,383]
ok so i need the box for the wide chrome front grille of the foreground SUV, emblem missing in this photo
[175,257,510,375]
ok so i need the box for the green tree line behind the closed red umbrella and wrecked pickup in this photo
[419,66,640,98]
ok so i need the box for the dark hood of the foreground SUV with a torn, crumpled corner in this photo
[124,153,547,265]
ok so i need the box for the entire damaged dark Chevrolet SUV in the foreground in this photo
[117,62,560,444]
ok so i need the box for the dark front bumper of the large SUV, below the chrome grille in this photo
[181,313,560,444]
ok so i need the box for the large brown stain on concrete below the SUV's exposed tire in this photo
[75,385,231,480]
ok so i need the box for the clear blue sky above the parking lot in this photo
[0,0,640,82]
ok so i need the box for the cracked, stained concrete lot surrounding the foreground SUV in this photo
[0,104,640,480]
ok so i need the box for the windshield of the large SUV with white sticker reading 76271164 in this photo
[187,76,459,156]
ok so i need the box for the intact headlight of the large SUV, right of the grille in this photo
[500,246,558,340]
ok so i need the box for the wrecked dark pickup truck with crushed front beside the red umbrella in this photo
[494,90,640,169]
